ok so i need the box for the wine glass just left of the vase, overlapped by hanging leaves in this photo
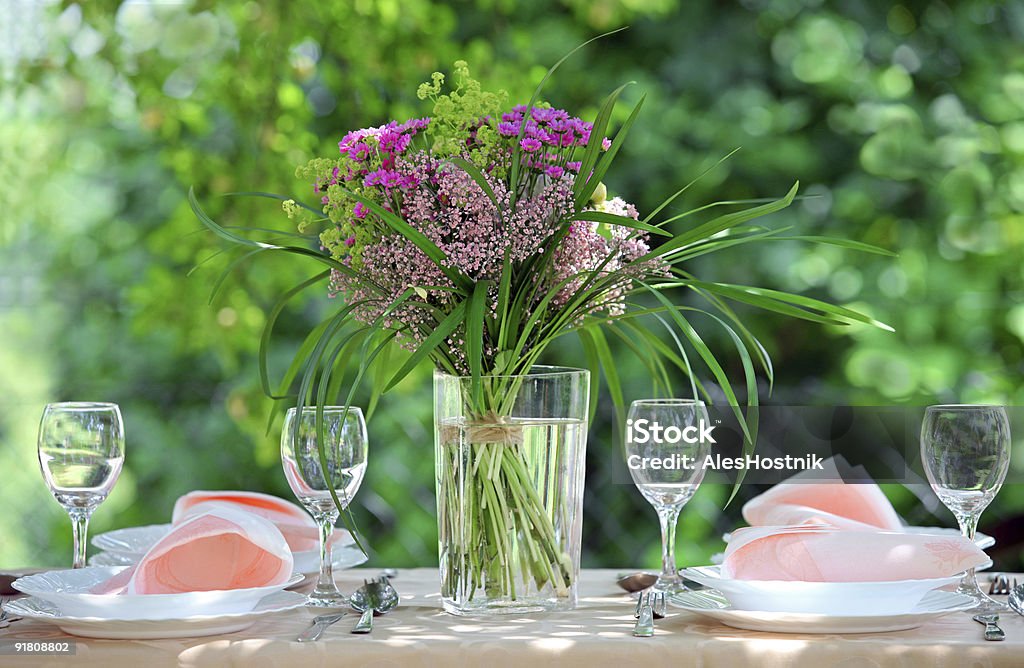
[281,406,367,608]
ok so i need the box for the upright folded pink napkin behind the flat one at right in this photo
[742,458,902,531]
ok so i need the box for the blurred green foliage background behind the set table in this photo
[0,0,1024,570]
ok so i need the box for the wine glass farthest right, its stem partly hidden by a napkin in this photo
[921,405,1010,612]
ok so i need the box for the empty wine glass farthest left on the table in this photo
[38,402,125,569]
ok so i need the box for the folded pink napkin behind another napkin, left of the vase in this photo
[171,491,349,552]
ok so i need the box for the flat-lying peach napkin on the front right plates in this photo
[722,524,988,582]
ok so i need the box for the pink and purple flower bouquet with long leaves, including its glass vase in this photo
[190,44,880,613]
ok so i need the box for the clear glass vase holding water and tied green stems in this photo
[434,366,590,615]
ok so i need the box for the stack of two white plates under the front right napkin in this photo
[669,566,974,633]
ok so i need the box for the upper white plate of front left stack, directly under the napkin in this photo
[11,567,302,620]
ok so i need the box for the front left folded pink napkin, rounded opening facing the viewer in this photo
[92,506,293,594]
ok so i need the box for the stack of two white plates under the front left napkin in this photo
[4,567,306,638]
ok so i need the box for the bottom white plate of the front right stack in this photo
[669,589,974,633]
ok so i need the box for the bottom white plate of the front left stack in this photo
[4,591,306,640]
